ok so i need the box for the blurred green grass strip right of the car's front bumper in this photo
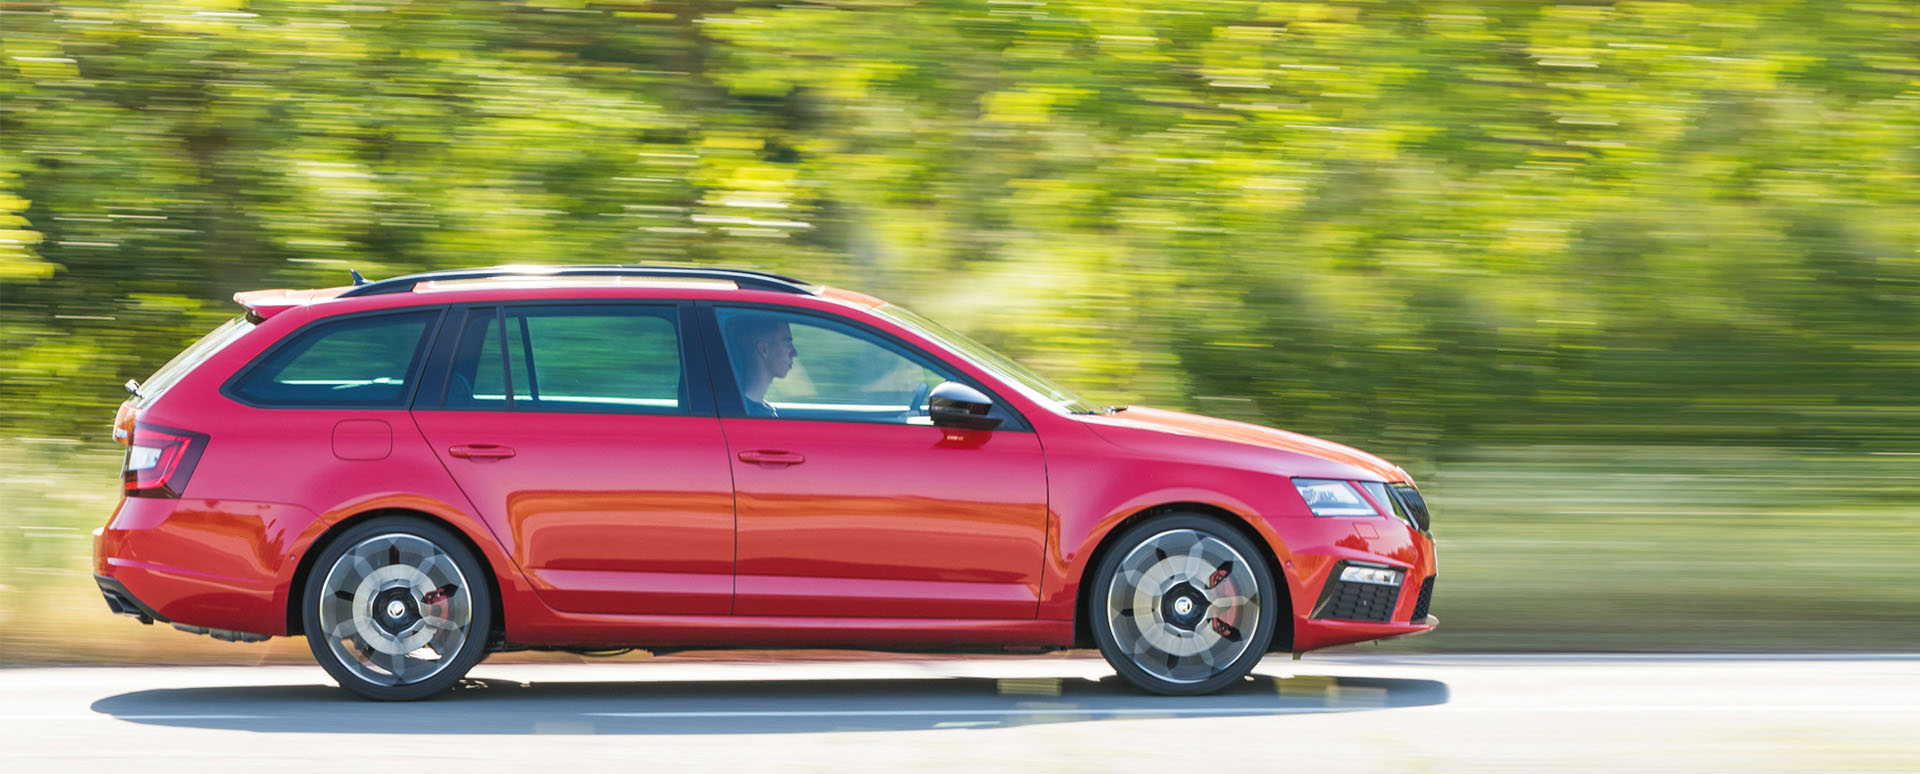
[1384,446,1920,651]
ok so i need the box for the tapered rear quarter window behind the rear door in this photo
[230,309,440,407]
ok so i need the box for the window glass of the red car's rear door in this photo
[445,305,685,413]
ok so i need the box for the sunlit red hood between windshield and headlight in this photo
[1081,405,1411,482]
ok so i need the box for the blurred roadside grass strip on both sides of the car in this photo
[0,440,1920,665]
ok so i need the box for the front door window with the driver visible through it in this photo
[714,307,954,424]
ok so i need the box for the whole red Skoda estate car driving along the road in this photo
[94,267,1436,699]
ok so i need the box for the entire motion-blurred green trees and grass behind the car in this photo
[0,0,1920,663]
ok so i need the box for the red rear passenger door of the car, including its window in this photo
[415,302,733,615]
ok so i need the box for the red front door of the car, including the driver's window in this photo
[708,305,1046,618]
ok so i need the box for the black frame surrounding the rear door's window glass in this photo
[413,298,714,417]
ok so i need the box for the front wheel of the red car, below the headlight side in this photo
[1083,513,1281,695]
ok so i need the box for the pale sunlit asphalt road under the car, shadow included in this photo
[0,655,1920,774]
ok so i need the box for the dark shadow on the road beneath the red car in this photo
[92,672,1448,734]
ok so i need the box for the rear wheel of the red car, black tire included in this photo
[300,517,493,701]
